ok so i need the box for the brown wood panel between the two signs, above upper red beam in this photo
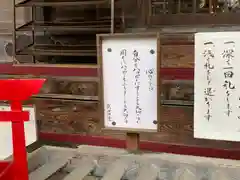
[161,45,194,68]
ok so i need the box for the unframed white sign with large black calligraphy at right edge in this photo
[194,32,240,141]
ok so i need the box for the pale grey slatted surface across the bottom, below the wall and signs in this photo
[25,146,240,180]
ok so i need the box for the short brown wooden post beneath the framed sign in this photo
[126,133,140,152]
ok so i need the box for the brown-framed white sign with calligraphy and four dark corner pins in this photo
[98,33,160,132]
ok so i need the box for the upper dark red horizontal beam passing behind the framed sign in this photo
[0,64,194,80]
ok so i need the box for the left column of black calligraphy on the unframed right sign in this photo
[203,42,215,121]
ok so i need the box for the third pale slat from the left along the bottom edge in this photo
[102,159,129,180]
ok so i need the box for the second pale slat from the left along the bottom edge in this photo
[63,158,96,180]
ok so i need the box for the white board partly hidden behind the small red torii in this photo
[0,105,37,160]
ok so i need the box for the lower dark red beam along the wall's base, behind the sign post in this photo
[40,132,240,160]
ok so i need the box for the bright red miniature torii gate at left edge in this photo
[0,79,45,180]
